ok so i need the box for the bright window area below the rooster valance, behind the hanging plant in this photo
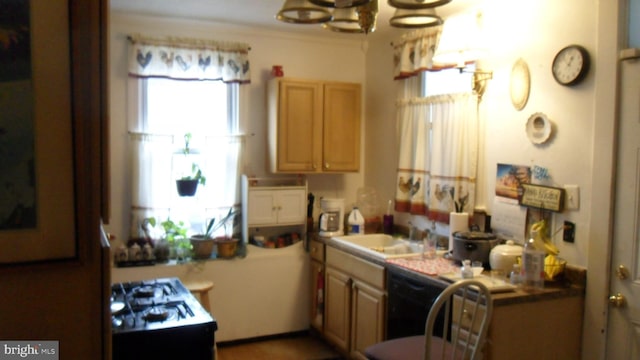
[130,78,242,233]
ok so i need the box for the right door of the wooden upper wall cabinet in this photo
[322,83,361,172]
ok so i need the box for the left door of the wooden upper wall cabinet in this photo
[275,80,322,173]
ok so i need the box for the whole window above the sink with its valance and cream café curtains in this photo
[394,29,479,223]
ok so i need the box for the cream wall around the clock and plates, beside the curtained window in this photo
[365,0,604,266]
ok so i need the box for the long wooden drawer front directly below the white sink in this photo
[325,246,386,290]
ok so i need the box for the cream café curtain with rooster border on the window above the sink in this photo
[396,93,479,223]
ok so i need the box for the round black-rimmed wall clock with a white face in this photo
[551,45,590,86]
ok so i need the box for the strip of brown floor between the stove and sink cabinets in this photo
[217,333,342,360]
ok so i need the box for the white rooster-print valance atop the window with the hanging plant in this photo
[129,35,251,84]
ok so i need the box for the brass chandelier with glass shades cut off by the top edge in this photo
[276,0,444,34]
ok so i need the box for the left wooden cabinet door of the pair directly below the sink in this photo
[324,266,351,352]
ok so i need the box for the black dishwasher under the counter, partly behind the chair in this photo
[387,267,444,339]
